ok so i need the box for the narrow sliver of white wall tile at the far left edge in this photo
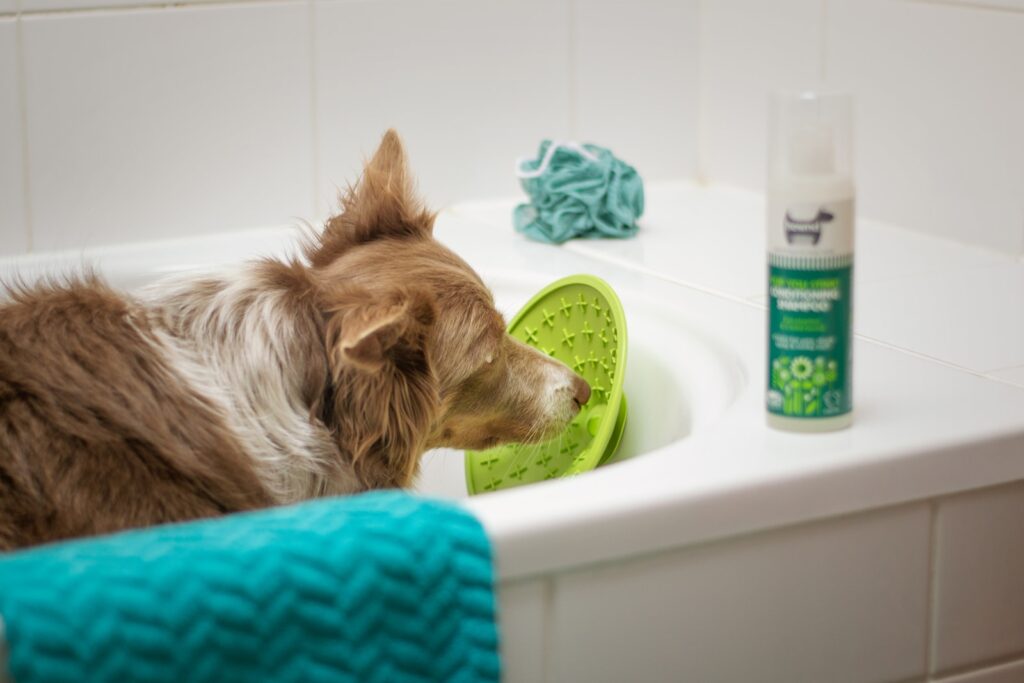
[0,19,29,254]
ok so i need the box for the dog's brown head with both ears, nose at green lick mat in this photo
[308,131,590,487]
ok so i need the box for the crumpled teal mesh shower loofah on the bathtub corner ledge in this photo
[513,140,643,244]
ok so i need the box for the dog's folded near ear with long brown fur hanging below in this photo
[325,289,440,489]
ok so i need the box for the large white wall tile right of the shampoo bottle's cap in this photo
[826,0,1024,254]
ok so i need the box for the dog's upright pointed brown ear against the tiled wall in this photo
[308,130,434,266]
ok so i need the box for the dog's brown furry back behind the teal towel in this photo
[0,279,271,549]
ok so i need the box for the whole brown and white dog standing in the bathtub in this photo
[0,131,590,549]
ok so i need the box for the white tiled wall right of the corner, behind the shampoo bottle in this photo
[699,0,1024,255]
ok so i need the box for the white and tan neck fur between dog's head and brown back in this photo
[142,262,361,503]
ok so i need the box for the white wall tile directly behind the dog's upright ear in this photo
[314,0,569,216]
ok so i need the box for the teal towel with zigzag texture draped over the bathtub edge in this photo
[0,493,500,683]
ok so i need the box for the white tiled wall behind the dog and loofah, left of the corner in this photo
[0,0,698,253]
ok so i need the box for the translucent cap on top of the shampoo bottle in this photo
[768,91,853,178]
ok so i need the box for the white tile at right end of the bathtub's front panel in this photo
[933,485,1024,672]
